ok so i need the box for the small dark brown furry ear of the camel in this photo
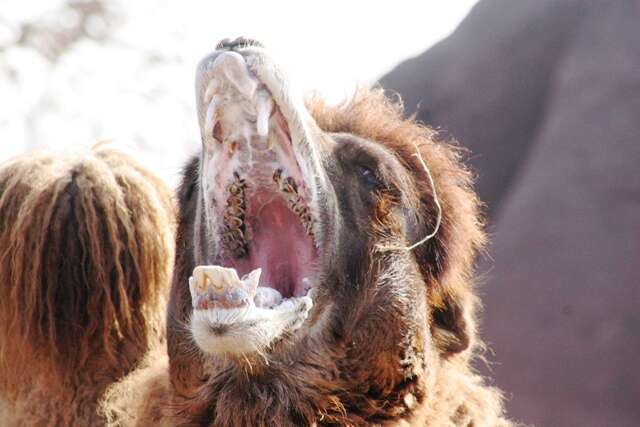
[431,296,471,357]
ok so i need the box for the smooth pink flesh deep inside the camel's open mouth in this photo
[243,193,315,298]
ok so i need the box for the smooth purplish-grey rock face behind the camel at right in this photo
[381,0,640,427]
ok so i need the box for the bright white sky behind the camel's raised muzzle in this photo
[0,0,476,184]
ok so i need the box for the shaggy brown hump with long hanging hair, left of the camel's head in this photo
[0,147,174,426]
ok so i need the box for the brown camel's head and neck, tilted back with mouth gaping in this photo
[159,38,512,426]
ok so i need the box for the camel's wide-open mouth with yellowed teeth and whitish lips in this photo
[190,44,318,358]
